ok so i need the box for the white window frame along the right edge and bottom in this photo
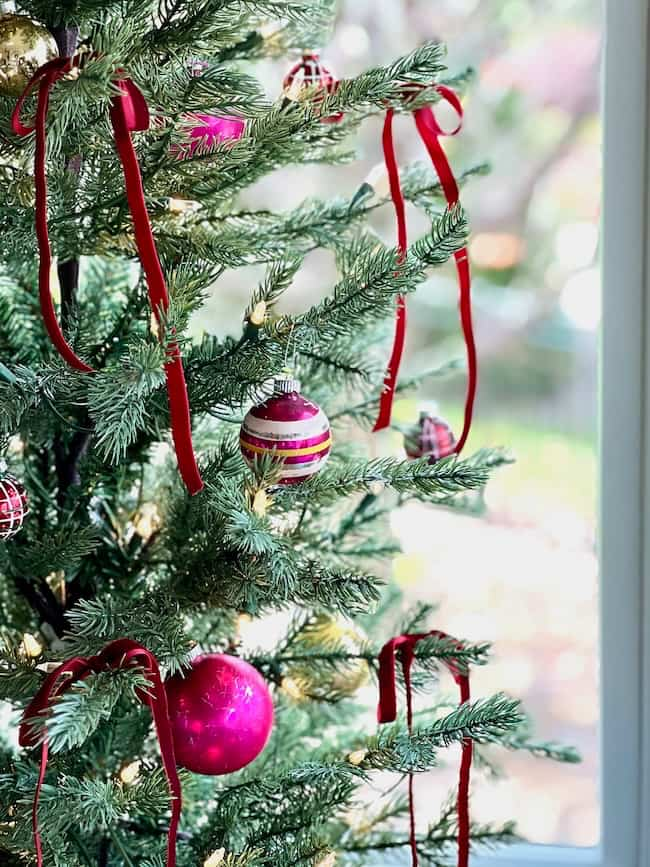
[472,0,650,867]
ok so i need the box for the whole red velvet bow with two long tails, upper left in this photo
[11,55,203,494]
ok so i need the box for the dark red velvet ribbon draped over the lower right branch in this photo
[377,629,472,867]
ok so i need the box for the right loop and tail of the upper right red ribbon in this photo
[415,96,478,454]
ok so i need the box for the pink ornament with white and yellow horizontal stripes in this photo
[239,377,332,485]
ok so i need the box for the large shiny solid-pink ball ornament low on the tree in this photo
[165,653,273,775]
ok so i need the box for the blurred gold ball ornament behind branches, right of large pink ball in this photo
[282,614,370,698]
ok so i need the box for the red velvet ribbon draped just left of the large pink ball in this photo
[19,638,182,867]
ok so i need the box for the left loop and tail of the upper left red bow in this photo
[11,56,92,373]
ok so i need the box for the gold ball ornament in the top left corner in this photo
[0,12,58,96]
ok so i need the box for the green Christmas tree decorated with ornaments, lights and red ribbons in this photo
[0,0,575,867]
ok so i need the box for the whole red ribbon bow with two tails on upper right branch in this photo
[373,85,478,454]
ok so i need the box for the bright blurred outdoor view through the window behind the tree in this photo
[201,0,602,845]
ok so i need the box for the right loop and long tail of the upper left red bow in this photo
[111,79,203,495]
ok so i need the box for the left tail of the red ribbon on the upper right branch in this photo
[373,108,408,431]
